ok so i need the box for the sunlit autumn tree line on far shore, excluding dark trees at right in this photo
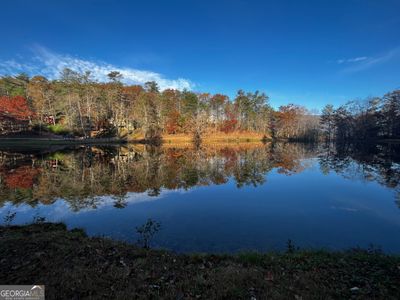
[0,68,318,140]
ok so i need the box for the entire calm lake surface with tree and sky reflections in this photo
[0,143,400,252]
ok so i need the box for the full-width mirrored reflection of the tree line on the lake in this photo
[0,143,400,211]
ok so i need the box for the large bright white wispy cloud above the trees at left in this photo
[0,46,194,90]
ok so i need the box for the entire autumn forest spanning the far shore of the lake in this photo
[0,68,400,142]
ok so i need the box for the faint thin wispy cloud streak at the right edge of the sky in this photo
[337,47,400,73]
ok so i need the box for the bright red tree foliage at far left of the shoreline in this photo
[0,96,34,121]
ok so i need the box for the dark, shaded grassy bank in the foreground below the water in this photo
[0,223,400,299]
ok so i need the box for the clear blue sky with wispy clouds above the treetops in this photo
[0,0,400,108]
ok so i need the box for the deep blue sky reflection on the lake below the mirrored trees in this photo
[0,160,400,252]
